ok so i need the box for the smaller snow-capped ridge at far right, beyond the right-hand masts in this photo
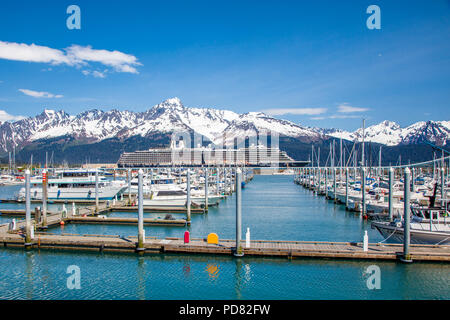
[324,120,450,146]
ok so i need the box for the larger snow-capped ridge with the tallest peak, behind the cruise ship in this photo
[0,98,322,151]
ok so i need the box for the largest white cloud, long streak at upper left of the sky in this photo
[0,41,142,73]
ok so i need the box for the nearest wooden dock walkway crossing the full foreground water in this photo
[0,226,450,262]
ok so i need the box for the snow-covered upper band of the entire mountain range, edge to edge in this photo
[0,97,450,151]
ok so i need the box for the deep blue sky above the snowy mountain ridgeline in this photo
[0,0,450,130]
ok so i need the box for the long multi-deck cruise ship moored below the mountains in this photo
[117,146,303,168]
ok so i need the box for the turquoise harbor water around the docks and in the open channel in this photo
[0,176,450,299]
